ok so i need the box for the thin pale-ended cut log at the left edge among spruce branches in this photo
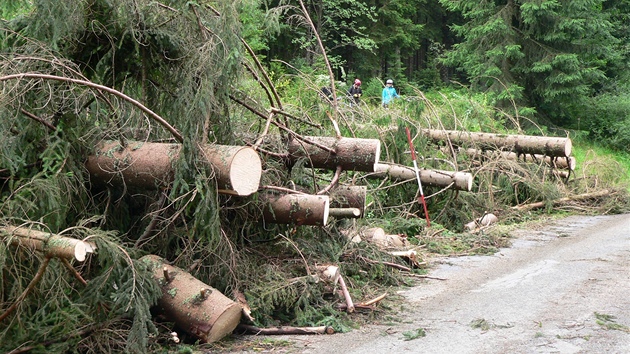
[0,226,96,262]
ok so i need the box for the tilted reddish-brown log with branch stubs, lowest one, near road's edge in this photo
[140,255,242,343]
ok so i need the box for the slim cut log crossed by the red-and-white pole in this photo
[370,163,473,192]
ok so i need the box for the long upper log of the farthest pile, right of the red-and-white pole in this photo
[422,129,572,157]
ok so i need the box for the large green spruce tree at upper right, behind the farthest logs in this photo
[440,0,618,124]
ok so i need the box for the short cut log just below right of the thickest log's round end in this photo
[263,194,330,226]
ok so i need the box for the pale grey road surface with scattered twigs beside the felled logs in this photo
[226,214,630,354]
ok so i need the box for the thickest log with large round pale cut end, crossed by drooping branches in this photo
[86,141,262,196]
